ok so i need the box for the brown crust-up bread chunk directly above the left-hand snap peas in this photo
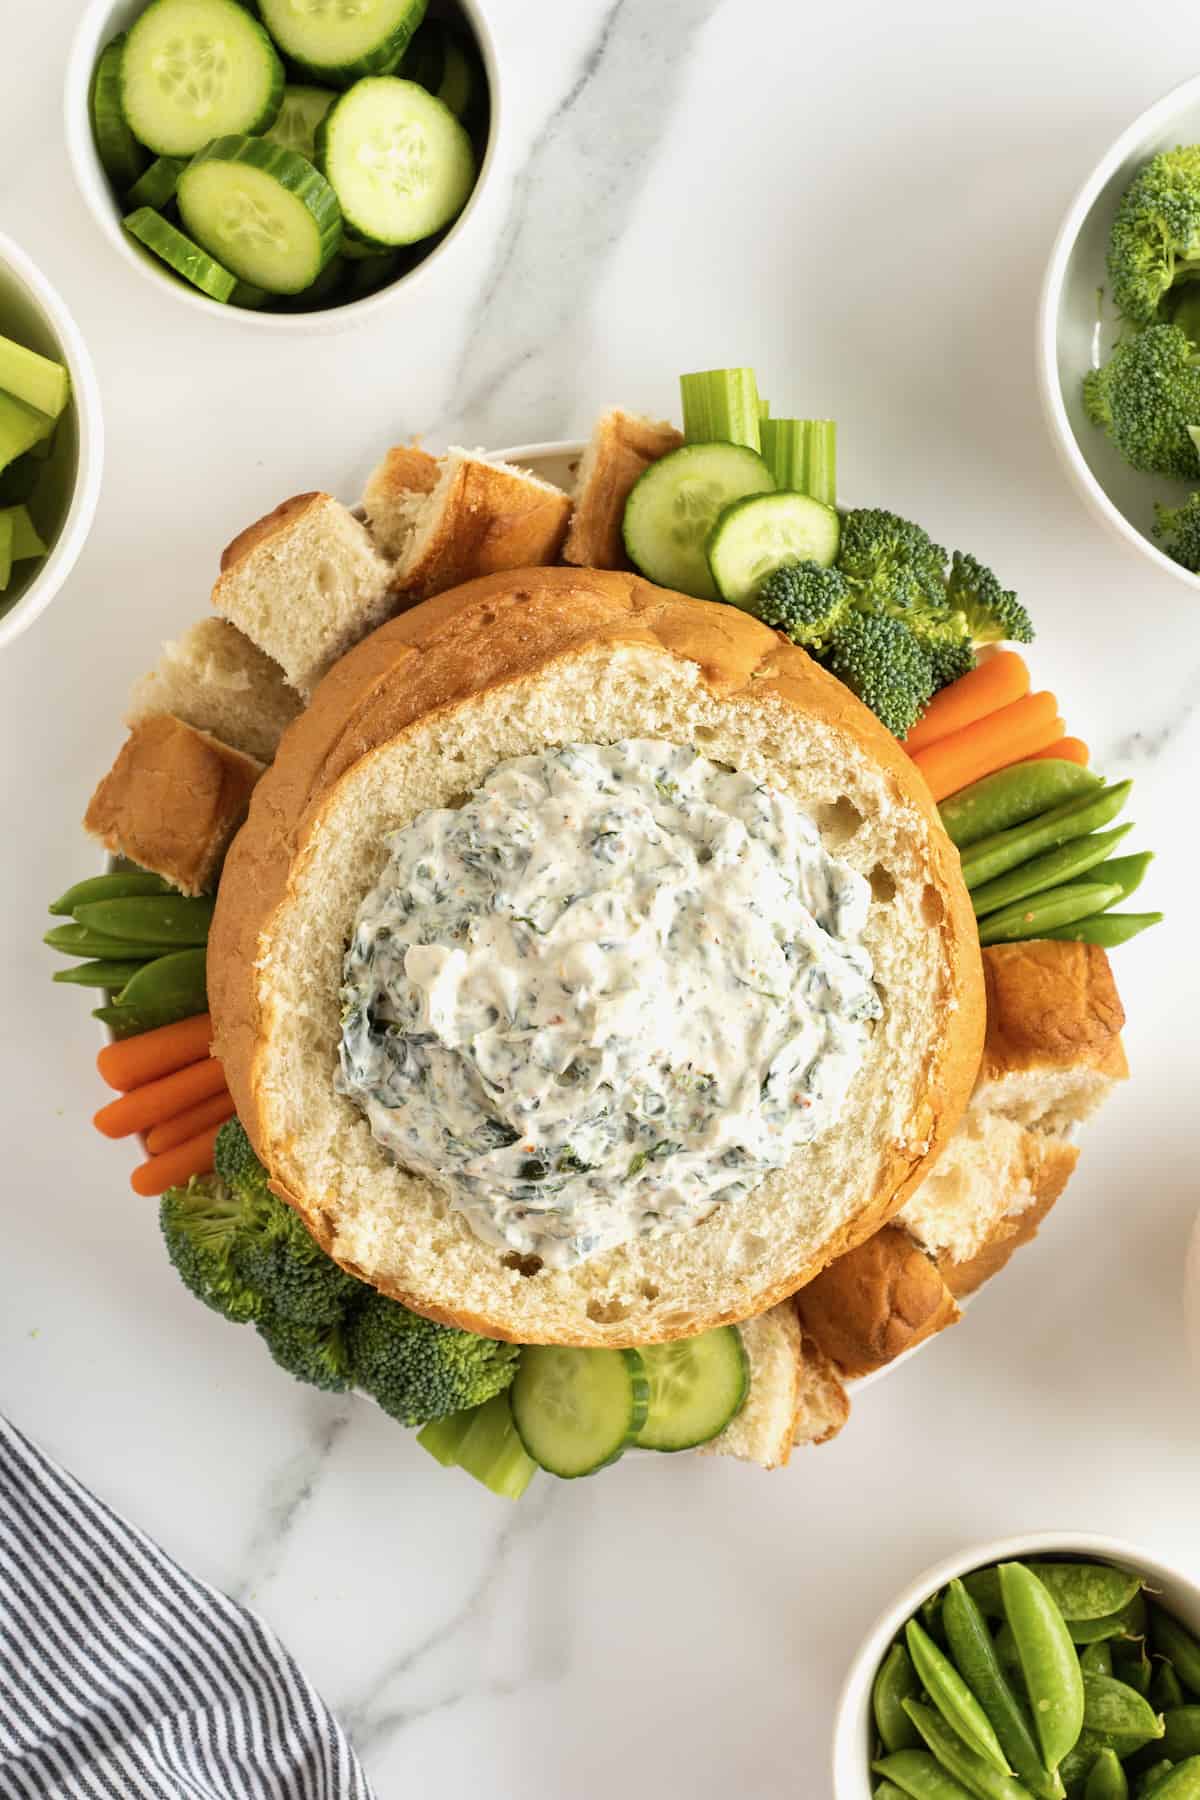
[83,716,263,895]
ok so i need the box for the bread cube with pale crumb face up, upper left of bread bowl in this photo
[212,493,394,698]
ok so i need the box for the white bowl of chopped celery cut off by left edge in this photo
[0,232,104,650]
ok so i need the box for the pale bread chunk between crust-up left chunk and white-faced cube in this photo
[124,617,304,763]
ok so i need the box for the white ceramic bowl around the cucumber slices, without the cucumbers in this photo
[65,0,500,333]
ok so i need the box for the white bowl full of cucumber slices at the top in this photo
[67,0,498,331]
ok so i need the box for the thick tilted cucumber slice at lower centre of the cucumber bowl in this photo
[178,137,342,293]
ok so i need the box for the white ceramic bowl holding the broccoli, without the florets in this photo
[1038,76,1200,589]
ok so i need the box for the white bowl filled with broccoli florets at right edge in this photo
[1038,76,1200,587]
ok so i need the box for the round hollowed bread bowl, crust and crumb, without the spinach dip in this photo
[209,569,984,1346]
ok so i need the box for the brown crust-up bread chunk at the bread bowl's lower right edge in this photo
[795,1226,961,1375]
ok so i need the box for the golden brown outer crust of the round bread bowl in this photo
[209,569,984,1345]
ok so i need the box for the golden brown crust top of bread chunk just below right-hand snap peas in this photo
[979,938,1130,1084]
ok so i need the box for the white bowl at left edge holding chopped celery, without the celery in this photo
[0,232,104,650]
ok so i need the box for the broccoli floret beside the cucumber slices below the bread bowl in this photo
[347,1292,520,1426]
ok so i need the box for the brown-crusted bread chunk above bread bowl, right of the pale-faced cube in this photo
[379,450,570,601]
